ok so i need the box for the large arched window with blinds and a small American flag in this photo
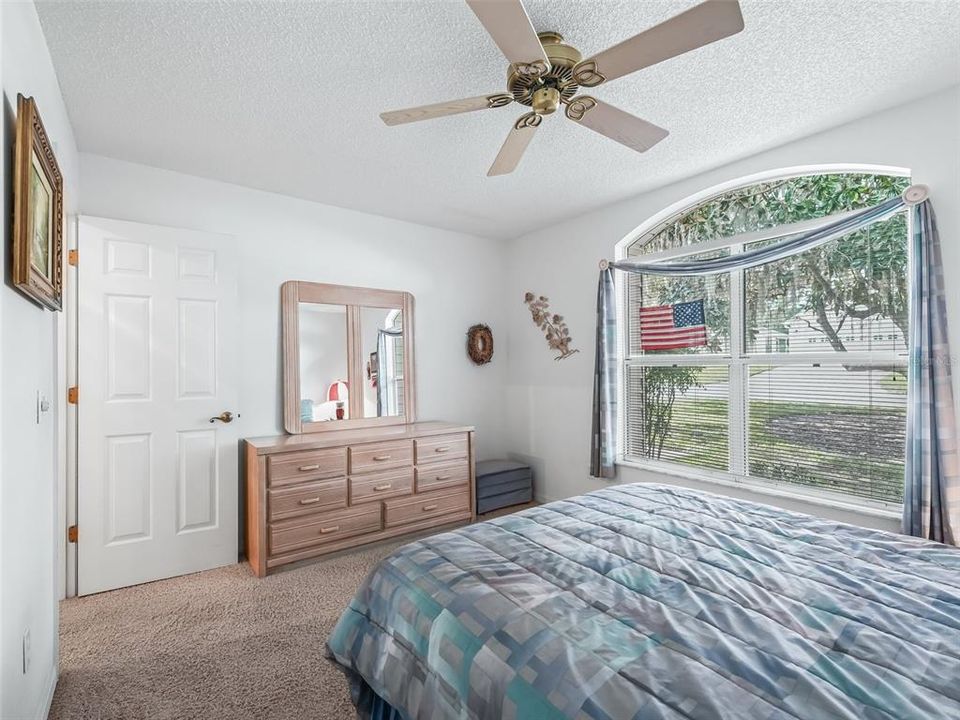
[619,172,910,504]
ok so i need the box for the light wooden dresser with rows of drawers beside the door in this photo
[244,422,476,577]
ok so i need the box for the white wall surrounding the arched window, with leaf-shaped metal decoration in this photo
[506,87,960,529]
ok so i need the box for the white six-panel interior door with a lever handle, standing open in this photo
[77,217,239,595]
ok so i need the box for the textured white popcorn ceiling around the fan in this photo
[38,0,960,238]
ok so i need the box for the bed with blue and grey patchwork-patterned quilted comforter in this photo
[327,484,960,720]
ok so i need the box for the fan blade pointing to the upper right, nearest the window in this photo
[573,0,743,87]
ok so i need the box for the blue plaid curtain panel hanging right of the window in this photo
[903,200,960,545]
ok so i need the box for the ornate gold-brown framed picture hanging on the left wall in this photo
[12,95,63,310]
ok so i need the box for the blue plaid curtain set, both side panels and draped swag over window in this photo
[590,185,960,544]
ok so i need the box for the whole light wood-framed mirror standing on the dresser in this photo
[281,281,416,434]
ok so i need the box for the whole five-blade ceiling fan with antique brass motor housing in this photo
[380,0,743,176]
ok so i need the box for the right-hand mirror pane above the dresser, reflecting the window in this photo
[360,307,404,418]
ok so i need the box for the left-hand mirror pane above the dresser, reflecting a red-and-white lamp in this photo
[298,303,350,422]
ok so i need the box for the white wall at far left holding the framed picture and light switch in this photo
[0,2,79,718]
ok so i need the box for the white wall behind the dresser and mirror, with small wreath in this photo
[80,154,506,457]
